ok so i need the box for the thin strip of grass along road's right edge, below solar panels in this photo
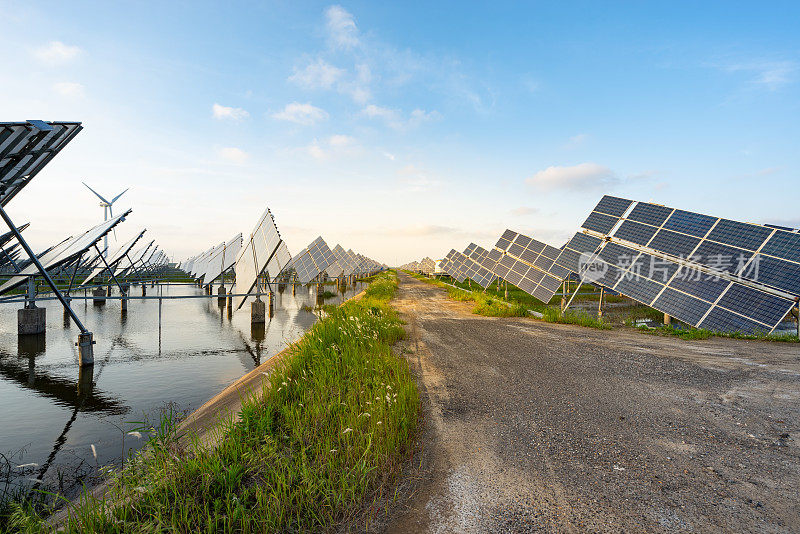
[409,272,798,343]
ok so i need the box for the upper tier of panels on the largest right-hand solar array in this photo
[583,196,800,295]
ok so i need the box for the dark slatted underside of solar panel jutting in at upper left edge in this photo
[0,121,82,206]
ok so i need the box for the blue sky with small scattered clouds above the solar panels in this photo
[0,0,800,265]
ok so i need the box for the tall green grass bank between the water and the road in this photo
[8,273,419,532]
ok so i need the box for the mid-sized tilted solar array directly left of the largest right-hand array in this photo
[490,230,599,303]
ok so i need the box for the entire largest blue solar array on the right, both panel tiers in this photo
[583,196,800,332]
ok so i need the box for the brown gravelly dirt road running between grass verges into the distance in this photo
[387,274,800,533]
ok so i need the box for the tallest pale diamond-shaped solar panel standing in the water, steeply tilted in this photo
[233,209,291,310]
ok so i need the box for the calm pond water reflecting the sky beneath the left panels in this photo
[0,284,361,496]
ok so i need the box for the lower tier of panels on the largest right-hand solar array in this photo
[587,240,793,332]
